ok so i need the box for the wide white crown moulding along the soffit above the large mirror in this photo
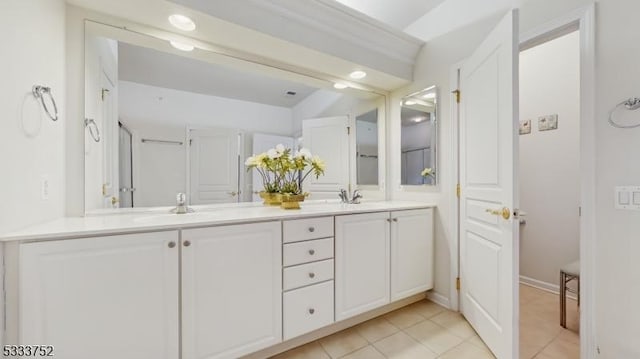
[172,0,424,80]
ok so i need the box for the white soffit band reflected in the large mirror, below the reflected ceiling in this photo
[119,81,293,136]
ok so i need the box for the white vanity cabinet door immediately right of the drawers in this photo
[335,212,390,320]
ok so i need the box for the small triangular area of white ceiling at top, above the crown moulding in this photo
[335,0,445,30]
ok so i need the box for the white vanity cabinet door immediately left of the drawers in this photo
[182,222,282,359]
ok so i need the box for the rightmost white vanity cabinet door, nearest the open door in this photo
[391,208,434,300]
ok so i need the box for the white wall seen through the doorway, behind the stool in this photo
[519,32,580,290]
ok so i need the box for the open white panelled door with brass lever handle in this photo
[460,10,518,359]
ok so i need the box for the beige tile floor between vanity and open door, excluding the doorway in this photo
[274,300,494,359]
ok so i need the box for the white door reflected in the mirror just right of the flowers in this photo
[302,116,351,198]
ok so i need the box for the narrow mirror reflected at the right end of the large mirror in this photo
[356,108,378,185]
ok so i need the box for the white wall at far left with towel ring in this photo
[0,0,68,232]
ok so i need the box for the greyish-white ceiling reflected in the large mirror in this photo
[118,42,316,108]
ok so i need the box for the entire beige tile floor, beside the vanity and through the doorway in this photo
[274,285,580,359]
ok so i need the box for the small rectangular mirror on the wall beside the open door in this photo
[401,86,438,186]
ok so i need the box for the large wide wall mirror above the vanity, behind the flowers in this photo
[85,21,385,212]
